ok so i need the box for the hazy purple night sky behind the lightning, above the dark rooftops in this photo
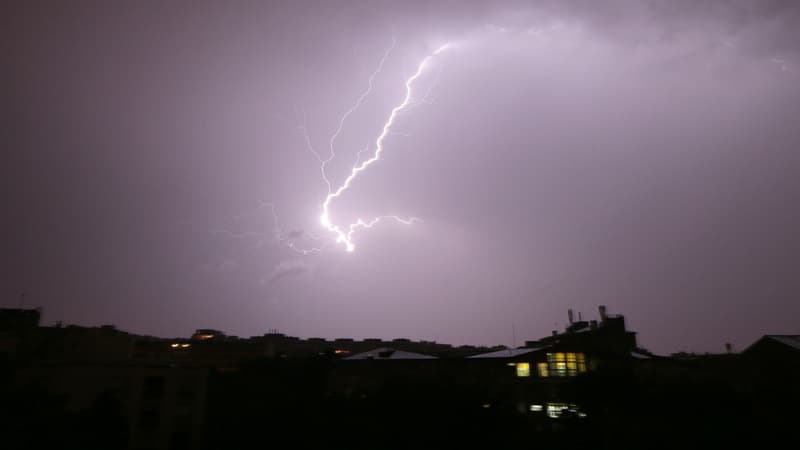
[6,0,800,353]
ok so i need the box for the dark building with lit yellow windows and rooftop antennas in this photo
[460,306,655,426]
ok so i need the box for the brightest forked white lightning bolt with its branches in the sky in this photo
[318,43,451,252]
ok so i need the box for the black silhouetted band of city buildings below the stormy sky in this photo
[0,307,800,450]
